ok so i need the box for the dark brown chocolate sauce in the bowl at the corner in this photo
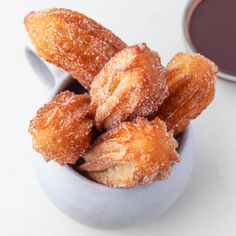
[189,0,236,75]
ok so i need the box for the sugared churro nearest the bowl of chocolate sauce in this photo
[157,53,218,135]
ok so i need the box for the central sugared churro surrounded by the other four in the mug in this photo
[90,43,168,130]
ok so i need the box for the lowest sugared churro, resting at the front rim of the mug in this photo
[80,117,180,187]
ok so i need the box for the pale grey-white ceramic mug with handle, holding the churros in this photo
[26,48,194,229]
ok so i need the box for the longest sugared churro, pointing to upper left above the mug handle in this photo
[25,8,126,88]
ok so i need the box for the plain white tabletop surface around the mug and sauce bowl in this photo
[0,0,236,236]
